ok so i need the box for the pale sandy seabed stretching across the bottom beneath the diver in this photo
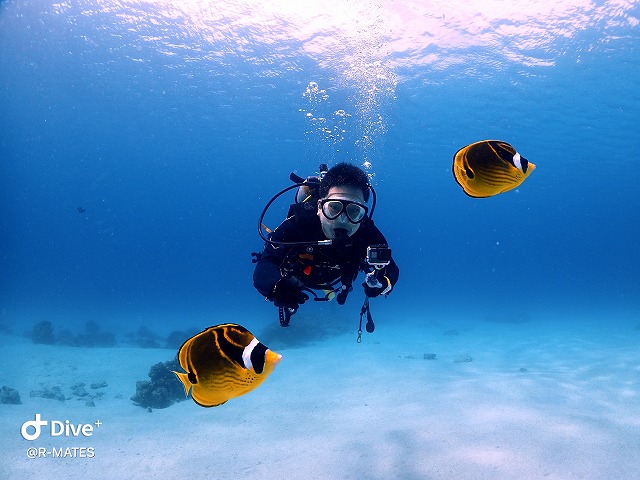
[0,319,640,480]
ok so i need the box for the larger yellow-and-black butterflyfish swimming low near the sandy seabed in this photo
[173,323,282,407]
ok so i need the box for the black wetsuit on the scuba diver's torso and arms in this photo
[253,208,399,304]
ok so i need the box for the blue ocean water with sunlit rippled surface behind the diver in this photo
[0,0,640,333]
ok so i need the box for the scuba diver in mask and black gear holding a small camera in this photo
[253,163,399,334]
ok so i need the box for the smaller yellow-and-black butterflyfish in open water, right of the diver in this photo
[453,140,536,198]
